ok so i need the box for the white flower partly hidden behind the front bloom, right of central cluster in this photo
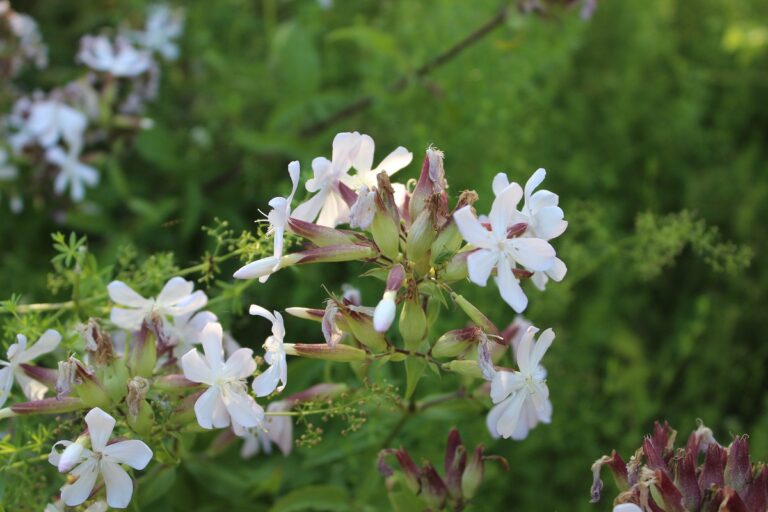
[493,169,568,290]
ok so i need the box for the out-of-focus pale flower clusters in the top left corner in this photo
[0,2,183,208]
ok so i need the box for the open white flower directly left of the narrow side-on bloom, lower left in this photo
[181,323,264,433]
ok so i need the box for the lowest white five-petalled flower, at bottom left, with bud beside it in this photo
[48,407,152,508]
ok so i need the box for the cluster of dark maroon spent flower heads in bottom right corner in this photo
[592,422,768,512]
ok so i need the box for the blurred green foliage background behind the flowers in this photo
[0,0,768,511]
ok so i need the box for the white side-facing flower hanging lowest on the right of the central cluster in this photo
[487,327,555,441]
